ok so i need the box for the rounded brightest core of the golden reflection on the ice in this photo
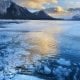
[27,32,56,55]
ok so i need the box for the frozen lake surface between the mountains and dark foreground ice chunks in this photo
[0,20,80,80]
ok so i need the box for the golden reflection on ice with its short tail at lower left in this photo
[23,32,57,62]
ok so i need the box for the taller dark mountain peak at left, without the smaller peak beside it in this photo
[0,2,34,19]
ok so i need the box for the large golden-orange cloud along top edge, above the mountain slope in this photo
[13,0,58,9]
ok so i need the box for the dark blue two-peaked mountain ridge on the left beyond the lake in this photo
[0,2,55,20]
